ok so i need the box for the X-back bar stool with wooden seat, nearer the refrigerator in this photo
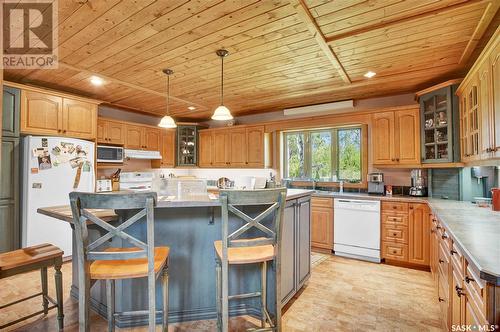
[69,192,170,332]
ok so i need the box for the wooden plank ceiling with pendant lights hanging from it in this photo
[4,0,500,120]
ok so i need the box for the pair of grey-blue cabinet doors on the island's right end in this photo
[281,196,311,305]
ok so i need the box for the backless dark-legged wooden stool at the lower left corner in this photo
[0,243,64,330]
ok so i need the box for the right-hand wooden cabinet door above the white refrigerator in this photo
[62,98,97,139]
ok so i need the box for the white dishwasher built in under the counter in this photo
[333,198,380,263]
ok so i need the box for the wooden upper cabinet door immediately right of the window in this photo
[372,112,396,165]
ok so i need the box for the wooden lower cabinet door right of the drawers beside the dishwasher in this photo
[408,203,430,265]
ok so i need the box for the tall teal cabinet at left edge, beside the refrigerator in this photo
[0,86,21,252]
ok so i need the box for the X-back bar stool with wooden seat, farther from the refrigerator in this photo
[214,188,286,332]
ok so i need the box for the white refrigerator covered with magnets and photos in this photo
[21,136,95,257]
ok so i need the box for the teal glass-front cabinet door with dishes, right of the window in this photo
[420,87,454,163]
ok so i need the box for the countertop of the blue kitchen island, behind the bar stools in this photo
[37,189,314,222]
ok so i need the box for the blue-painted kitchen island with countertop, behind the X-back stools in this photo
[38,189,312,327]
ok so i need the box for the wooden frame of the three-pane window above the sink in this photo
[282,124,362,186]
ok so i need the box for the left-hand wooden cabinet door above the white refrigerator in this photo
[21,90,63,136]
